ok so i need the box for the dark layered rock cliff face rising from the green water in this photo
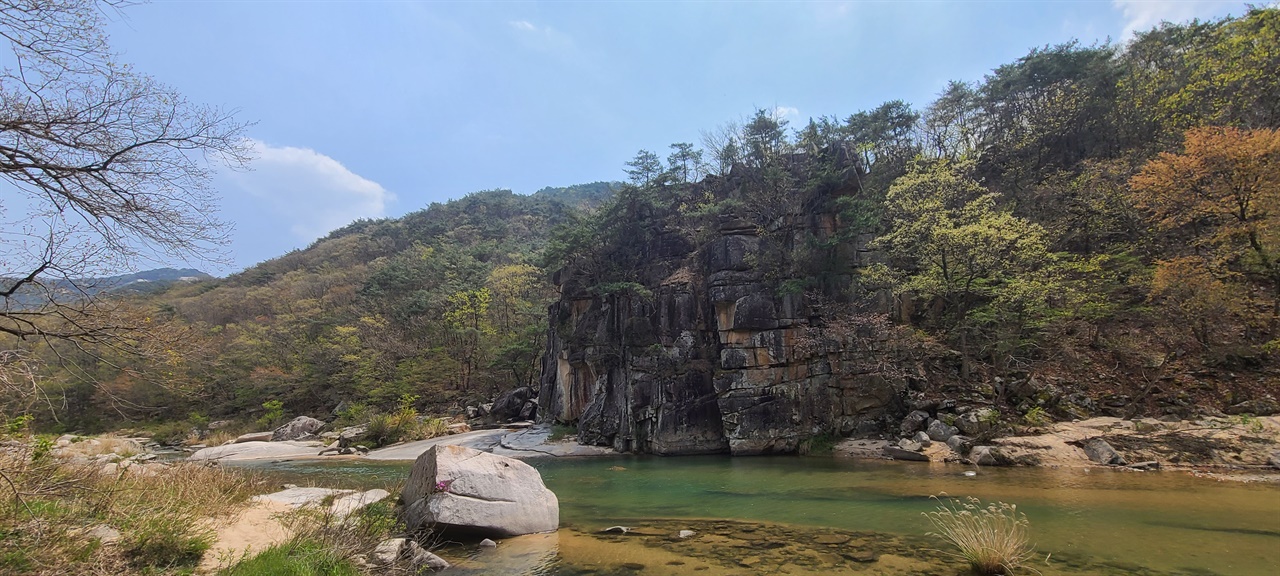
[539,168,906,454]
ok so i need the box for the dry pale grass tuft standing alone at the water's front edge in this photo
[924,497,1038,575]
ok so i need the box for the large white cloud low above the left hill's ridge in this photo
[232,140,396,242]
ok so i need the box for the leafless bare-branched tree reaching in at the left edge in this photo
[0,0,251,399]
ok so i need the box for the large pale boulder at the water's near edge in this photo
[401,445,559,538]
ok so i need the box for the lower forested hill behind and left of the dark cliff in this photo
[20,182,611,429]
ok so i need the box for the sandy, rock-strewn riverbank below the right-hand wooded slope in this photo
[833,416,1280,483]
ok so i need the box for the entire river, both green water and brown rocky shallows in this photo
[232,457,1280,575]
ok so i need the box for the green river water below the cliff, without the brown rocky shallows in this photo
[240,457,1280,575]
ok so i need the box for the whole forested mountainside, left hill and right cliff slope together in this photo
[12,9,1280,437]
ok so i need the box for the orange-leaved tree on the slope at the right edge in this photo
[1129,127,1280,324]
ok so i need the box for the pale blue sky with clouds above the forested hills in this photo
[94,0,1247,275]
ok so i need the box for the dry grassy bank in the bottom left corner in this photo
[0,438,261,576]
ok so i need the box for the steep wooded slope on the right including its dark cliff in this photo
[527,9,1280,454]
